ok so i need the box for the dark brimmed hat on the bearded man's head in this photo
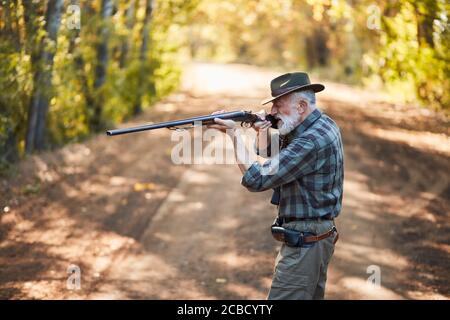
[261,72,325,104]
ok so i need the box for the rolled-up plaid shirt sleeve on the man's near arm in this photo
[241,138,317,192]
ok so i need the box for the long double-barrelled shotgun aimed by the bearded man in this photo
[106,111,278,136]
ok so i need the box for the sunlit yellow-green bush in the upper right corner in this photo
[371,0,450,109]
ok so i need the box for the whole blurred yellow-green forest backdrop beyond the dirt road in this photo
[0,0,450,168]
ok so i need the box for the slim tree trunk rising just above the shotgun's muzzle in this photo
[89,0,113,132]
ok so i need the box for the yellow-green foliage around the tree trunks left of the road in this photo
[0,0,198,166]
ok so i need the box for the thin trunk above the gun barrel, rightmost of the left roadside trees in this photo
[133,0,155,115]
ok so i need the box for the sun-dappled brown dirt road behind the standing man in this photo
[0,64,450,299]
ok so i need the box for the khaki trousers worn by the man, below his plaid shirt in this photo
[267,220,336,300]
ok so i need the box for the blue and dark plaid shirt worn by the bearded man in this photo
[241,109,344,218]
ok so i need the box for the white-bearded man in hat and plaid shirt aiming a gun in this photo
[210,72,344,299]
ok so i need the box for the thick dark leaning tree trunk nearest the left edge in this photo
[25,0,64,153]
